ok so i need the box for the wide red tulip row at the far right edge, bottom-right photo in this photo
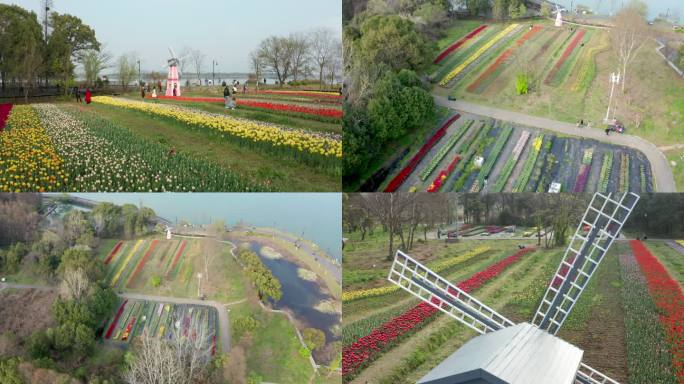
[630,240,684,383]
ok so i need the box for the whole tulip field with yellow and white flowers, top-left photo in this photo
[0,97,342,192]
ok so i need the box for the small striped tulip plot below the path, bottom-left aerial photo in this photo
[103,299,218,356]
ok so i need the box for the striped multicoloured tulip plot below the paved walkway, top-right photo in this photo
[383,114,653,193]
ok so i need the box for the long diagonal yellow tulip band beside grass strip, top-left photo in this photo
[93,96,342,158]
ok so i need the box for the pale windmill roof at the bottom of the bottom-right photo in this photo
[418,323,584,384]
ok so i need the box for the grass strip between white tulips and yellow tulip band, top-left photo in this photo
[60,104,340,191]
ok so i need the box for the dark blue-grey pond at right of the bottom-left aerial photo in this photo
[250,243,340,341]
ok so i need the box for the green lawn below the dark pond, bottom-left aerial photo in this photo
[230,302,313,383]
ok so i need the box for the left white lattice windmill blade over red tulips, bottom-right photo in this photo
[387,251,514,334]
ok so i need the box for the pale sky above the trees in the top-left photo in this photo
[6,0,342,73]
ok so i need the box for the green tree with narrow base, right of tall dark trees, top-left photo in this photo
[48,12,100,95]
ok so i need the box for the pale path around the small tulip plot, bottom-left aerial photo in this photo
[0,283,232,353]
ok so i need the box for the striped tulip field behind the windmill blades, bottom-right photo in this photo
[342,231,684,384]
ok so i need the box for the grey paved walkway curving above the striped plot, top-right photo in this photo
[435,96,677,192]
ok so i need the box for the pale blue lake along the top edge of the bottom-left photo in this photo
[68,193,342,260]
